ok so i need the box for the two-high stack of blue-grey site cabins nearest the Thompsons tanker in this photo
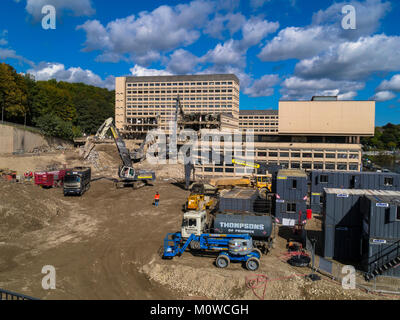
[275,170,308,226]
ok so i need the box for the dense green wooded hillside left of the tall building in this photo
[0,63,115,140]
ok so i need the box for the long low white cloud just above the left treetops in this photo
[27,62,115,90]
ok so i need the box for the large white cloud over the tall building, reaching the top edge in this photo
[77,0,213,64]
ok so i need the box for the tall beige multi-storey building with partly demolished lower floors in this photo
[115,74,239,136]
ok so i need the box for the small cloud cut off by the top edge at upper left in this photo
[22,0,95,21]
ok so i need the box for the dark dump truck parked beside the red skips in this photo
[64,167,92,196]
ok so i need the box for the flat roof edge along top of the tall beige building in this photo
[126,74,240,83]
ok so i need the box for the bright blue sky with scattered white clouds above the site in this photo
[0,0,400,125]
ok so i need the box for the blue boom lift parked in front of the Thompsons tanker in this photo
[163,232,261,271]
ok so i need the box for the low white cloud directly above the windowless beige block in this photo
[281,76,365,100]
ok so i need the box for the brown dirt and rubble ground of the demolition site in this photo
[0,145,398,300]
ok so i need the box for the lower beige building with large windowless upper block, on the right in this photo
[197,97,375,177]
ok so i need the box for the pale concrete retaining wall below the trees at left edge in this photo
[0,124,72,154]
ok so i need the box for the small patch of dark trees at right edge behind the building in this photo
[361,123,400,150]
